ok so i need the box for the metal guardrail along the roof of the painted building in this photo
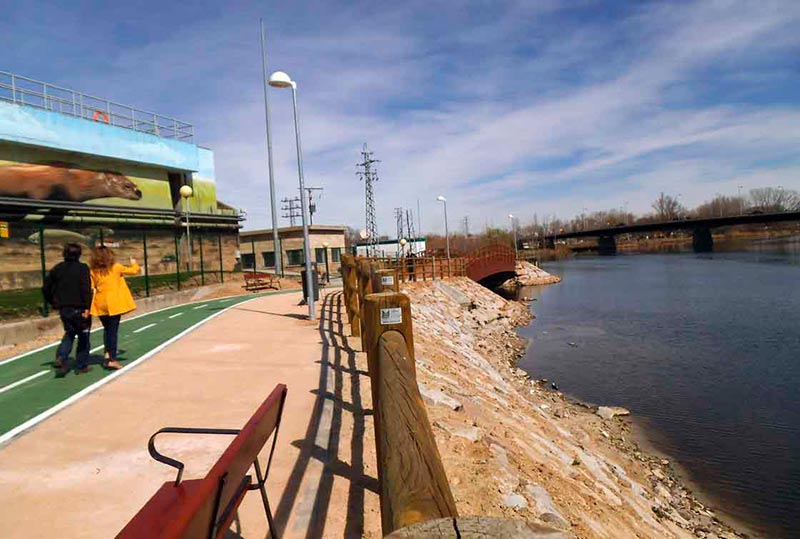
[0,71,194,142]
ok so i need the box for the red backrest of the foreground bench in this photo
[164,384,286,538]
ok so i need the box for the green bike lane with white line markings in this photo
[0,290,299,444]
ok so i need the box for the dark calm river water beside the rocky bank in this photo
[519,238,800,538]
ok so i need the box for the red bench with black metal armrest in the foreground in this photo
[117,384,286,539]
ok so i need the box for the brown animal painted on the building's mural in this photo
[0,163,142,202]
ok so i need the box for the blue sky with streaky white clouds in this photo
[0,0,800,235]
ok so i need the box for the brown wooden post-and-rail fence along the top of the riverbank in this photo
[342,252,567,539]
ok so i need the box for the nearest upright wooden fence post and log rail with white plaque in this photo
[364,292,458,535]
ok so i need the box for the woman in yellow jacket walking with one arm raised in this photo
[89,245,140,370]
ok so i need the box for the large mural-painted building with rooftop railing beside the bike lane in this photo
[0,72,241,318]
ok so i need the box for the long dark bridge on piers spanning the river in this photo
[532,211,800,255]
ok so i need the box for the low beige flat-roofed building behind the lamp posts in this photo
[239,225,347,275]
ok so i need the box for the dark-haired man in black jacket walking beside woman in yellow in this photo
[42,243,92,376]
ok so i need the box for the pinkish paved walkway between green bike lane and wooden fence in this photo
[0,291,379,538]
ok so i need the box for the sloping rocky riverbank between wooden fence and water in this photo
[404,276,744,539]
